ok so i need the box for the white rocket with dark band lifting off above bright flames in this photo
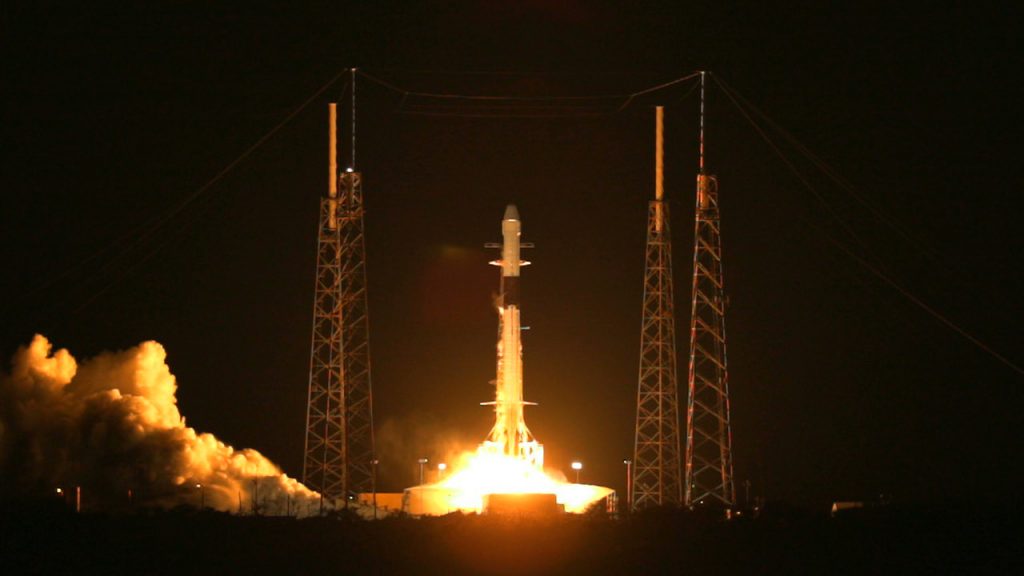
[483,204,544,468]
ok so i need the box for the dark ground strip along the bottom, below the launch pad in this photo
[0,503,1024,575]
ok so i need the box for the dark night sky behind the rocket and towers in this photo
[0,1,1024,502]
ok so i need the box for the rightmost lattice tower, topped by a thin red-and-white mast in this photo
[685,72,736,506]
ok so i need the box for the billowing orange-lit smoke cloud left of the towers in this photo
[0,335,319,516]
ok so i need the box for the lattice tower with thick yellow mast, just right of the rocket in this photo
[630,107,682,509]
